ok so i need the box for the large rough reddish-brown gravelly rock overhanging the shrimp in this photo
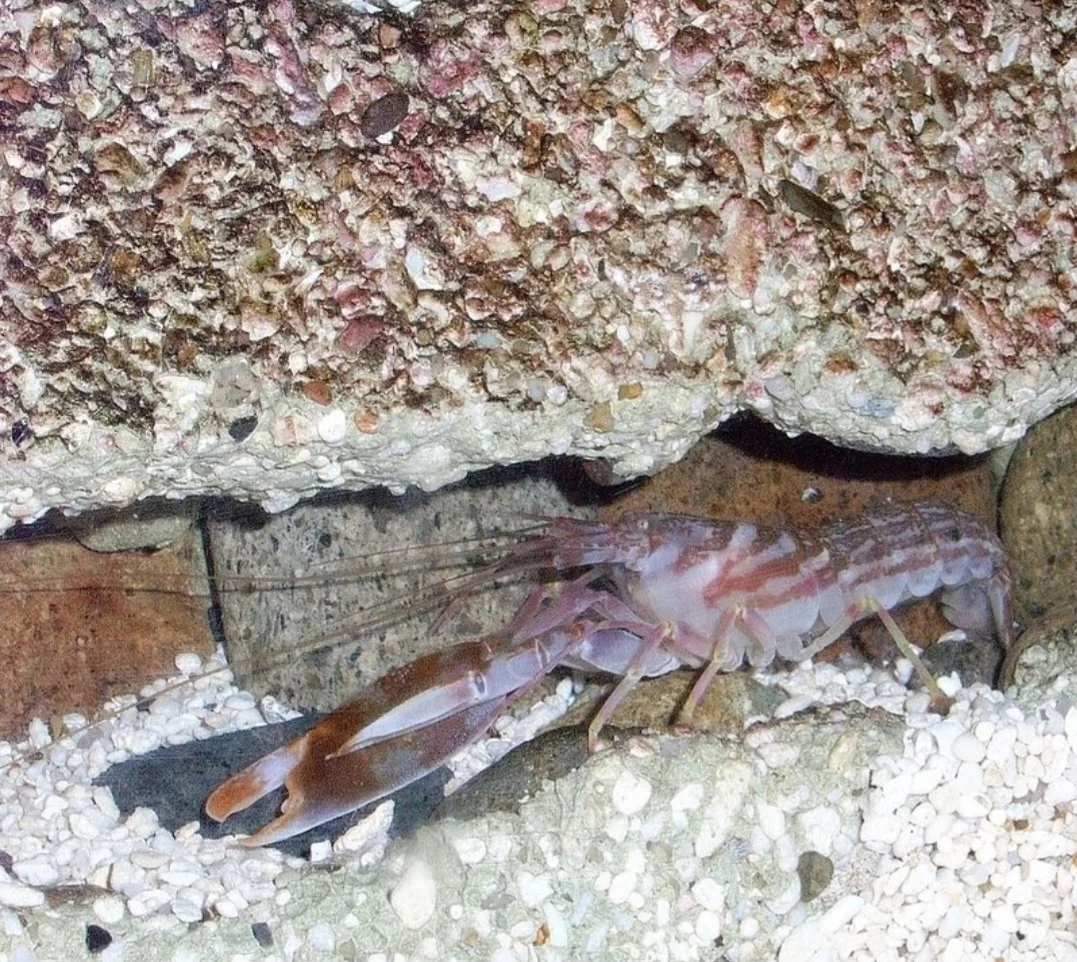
[0,0,1077,524]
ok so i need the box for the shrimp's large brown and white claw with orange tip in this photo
[206,584,603,847]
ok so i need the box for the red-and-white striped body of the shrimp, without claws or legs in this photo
[611,502,1012,670]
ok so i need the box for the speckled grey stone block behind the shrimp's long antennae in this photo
[209,465,592,710]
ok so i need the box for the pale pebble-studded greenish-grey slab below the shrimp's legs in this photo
[0,705,903,962]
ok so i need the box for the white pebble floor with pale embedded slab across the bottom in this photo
[0,656,1077,962]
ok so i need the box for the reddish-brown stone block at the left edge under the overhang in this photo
[0,517,213,738]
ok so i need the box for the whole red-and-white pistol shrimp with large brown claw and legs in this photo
[206,502,1013,846]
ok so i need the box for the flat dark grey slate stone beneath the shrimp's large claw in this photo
[96,714,449,856]
